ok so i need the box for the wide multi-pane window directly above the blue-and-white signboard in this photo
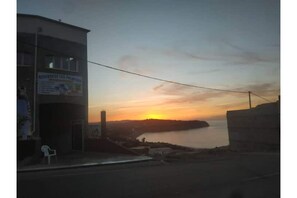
[45,55,78,72]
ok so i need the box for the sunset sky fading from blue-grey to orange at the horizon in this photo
[17,0,280,122]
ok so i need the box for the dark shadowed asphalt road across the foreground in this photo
[17,153,280,198]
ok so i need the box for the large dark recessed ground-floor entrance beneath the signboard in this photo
[39,103,86,153]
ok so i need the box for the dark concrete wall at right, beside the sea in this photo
[227,102,280,150]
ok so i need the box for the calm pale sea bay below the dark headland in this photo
[137,120,229,148]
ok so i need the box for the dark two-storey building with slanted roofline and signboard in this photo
[17,14,89,153]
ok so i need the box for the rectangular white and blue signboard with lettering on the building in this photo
[38,72,83,96]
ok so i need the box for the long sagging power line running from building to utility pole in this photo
[18,41,248,93]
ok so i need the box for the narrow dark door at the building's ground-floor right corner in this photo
[72,120,83,151]
